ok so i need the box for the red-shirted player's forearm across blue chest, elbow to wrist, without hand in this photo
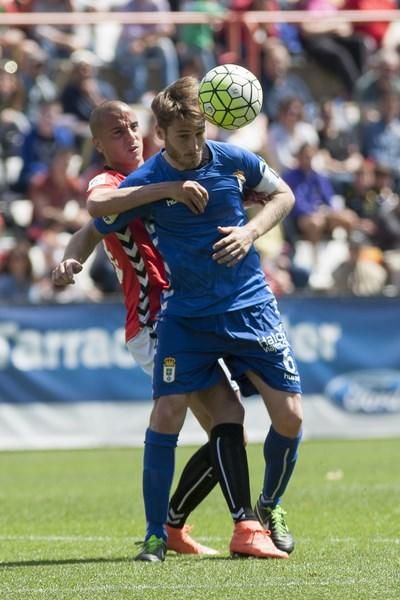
[87,182,181,217]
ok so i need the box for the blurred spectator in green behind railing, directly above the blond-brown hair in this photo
[179,0,225,77]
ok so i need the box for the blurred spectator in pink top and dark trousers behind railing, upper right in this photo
[299,0,367,96]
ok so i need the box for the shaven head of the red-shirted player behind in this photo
[93,108,143,174]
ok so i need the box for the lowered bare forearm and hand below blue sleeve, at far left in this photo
[51,223,103,287]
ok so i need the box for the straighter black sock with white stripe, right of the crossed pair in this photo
[210,423,257,523]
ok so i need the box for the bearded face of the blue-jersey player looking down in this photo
[157,120,206,171]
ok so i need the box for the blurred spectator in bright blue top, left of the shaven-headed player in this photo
[14,101,75,193]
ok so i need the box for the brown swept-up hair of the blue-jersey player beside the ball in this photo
[151,76,204,129]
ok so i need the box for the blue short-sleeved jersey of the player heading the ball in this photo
[95,141,277,317]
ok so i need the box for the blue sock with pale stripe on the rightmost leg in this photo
[262,426,301,507]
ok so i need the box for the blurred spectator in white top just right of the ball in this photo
[268,97,318,172]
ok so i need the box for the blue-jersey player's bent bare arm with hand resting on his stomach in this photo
[213,180,294,267]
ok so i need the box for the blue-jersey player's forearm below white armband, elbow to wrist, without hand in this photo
[245,182,294,242]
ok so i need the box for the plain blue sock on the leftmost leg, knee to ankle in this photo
[143,429,178,540]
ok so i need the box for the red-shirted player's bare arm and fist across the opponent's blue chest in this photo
[87,181,208,217]
